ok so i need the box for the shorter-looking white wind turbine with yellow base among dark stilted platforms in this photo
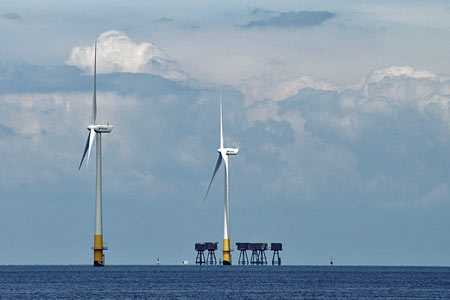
[203,92,239,265]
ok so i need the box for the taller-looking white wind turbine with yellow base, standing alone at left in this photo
[78,41,113,267]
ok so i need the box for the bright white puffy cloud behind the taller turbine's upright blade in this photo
[66,30,187,80]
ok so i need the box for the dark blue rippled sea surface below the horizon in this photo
[0,265,450,300]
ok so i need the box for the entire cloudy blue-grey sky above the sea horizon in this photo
[0,0,450,266]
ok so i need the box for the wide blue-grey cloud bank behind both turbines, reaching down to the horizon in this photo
[0,57,450,264]
